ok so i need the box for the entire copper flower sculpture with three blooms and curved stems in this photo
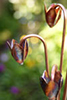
[7,4,67,100]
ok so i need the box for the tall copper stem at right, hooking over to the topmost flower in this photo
[56,4,66,72]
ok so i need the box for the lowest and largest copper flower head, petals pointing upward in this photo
[40,65,63,99]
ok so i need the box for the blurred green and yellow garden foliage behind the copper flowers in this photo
[0,0,67,100]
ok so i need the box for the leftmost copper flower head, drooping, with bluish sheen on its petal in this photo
[7,39,28,65]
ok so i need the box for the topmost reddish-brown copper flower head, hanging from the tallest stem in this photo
[44,4,61,27]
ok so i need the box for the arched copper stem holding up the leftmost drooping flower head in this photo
[20,34,49,75]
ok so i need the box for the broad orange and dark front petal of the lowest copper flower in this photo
[40,78,59,99]
